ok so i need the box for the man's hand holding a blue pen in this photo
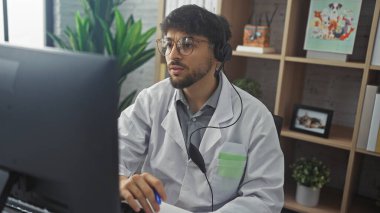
[119,173,166,213]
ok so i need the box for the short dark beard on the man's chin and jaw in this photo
[170,59,212,89]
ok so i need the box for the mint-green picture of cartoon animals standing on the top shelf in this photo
[304,0,362,58]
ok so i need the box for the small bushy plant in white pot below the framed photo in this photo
[290,157,330,207]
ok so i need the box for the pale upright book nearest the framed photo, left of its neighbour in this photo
[356,85,378,149]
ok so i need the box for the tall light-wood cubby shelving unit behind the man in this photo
[156,0,380,213]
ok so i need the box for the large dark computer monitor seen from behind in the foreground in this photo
[0,45,120,213]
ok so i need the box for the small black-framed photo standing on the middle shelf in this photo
[290,104,333,138]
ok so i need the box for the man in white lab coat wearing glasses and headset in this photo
[119,5,284,213]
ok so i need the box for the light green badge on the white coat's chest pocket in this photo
[218,152,246,178]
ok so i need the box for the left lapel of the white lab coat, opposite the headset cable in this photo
[161,91,187,153]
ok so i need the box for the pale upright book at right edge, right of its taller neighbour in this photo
[367,93,380,152]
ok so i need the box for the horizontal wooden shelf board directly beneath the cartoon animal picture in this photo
[285,56,365,69]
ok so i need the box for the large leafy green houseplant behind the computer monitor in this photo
[48,0,156,112]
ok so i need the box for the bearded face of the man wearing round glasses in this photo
[164,30,216,89]
